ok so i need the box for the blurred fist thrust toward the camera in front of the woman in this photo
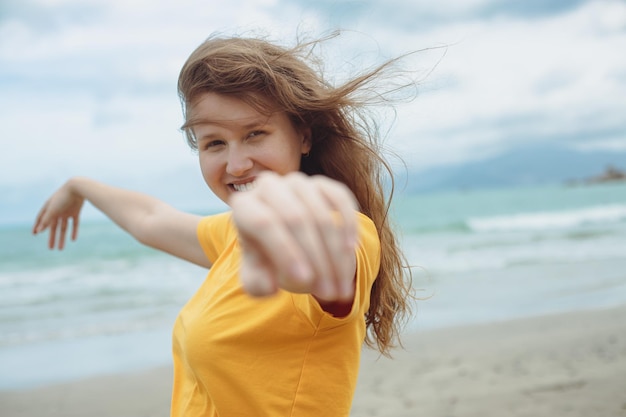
[229,172,357,302]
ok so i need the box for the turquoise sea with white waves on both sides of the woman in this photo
[0,183,626,390]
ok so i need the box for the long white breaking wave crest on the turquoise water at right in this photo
[467,204,626,233]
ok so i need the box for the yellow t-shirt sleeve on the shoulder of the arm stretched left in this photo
[196,212,236,263]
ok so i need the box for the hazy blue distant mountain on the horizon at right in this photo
[406,146,626,192]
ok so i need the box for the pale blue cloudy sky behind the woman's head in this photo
[0,0,626,220]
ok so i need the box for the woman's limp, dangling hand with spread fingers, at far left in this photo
[33,183,85,250]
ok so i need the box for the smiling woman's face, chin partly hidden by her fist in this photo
[191,93,311,202]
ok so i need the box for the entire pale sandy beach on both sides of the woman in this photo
[0,306,626,417]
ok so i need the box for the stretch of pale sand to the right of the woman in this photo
[352,307,626,417]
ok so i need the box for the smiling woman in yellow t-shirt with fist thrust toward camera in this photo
[33,33,409,416]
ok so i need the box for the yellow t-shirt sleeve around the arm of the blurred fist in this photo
[292,213,380,328]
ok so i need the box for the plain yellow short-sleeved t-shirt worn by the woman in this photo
[171,213,380,417]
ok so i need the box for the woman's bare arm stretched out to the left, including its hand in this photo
[33,178,211,268]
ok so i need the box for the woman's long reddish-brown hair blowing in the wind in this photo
[178,32,412,356]
